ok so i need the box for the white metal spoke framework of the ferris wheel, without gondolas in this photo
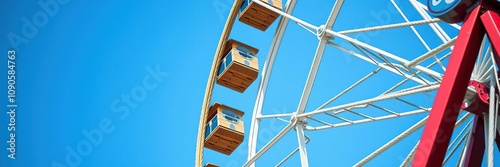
[243,0,500,167]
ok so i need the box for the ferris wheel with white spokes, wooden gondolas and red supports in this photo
[196,0,500,167]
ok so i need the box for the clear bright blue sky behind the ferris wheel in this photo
[0,0,498,167]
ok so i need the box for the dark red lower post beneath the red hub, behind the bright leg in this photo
[464,115,485,166]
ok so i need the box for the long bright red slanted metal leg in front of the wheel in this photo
[412,6,485,167]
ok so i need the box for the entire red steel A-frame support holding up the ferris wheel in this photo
[413,0,500,166]
